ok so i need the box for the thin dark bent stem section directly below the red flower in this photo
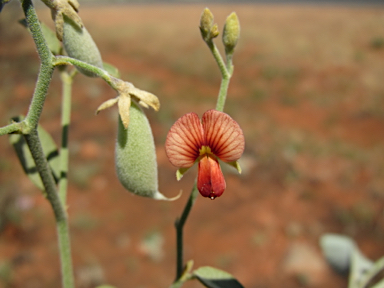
[175,184,199,281]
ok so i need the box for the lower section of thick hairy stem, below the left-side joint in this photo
[25,129,74,288]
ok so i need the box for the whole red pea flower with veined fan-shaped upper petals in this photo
[165,110,244,200]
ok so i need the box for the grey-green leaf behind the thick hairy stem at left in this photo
[9,117,60,191]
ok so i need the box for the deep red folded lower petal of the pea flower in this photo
[197,156,226,200]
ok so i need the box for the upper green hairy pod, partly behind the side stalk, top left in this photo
[63,17,103,77]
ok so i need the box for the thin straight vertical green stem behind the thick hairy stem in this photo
[59,70,76,204]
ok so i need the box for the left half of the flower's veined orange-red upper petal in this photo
[165,113,204,168]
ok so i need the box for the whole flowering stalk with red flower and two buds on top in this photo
[172,8,244,287]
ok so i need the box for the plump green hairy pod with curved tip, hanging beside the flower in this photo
[115,101,179,200]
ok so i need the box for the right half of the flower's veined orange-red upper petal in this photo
[202,110,244,162]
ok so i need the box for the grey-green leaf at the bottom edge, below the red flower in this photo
[193,266,244,288]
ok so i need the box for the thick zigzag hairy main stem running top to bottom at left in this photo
[18,0,74,288]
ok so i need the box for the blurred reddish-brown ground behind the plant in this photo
[0,1,384,288]
